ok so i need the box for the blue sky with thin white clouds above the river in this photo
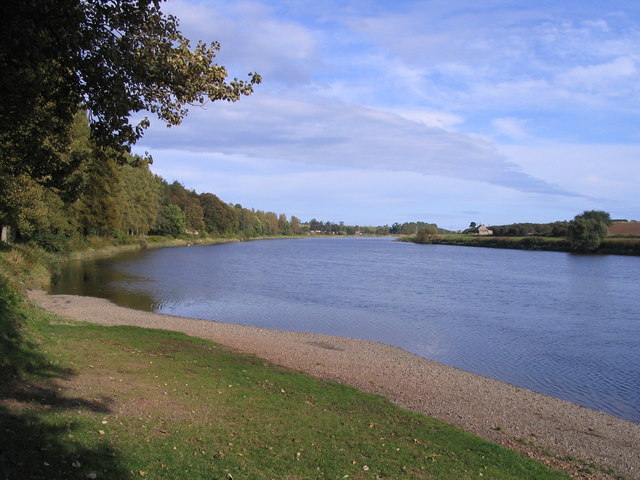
[136,0,640,230]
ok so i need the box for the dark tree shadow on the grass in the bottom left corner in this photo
[0,277,130,480]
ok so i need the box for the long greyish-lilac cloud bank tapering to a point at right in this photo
[139,94,570,195]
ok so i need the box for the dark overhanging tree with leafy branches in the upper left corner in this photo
[0,0,260,231]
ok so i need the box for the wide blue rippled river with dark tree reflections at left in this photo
[52,238,640,423]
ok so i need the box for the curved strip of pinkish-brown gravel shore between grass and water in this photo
[30,291,640,480]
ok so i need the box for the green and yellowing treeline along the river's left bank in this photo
[1,113,302,251]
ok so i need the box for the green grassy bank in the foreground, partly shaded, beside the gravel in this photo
[0,244,568,480]
